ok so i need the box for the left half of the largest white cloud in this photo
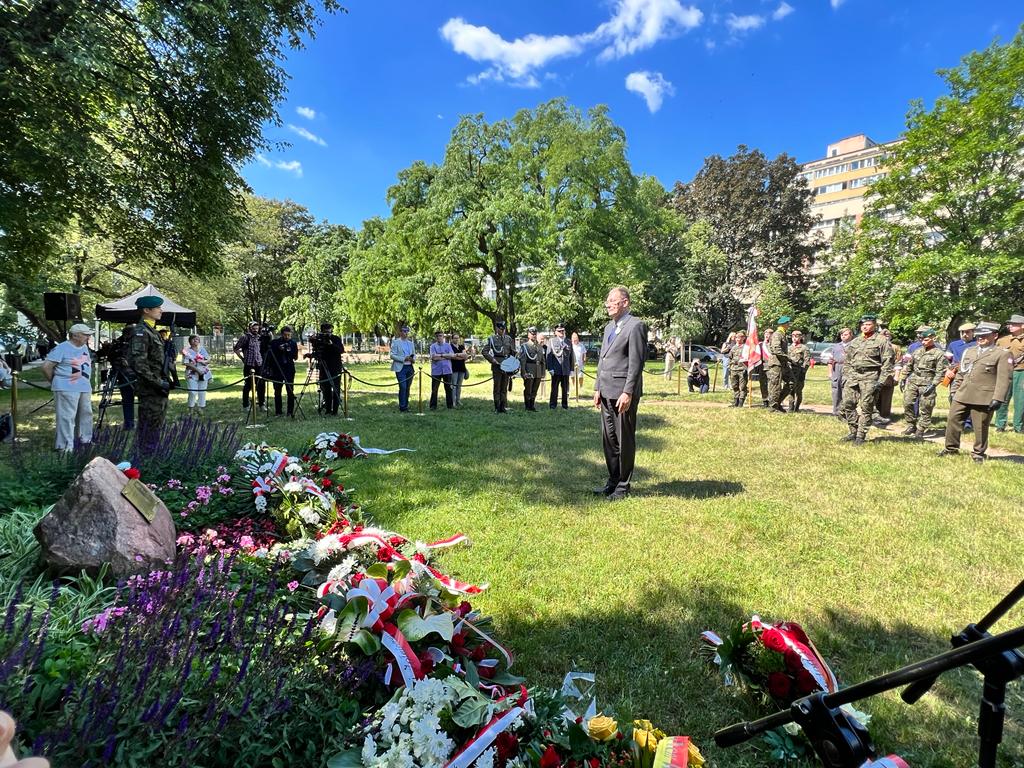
[441,18,583,83]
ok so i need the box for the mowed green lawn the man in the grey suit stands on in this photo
[2,364,1024,768]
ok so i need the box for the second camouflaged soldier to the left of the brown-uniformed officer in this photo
[839,314,896,445]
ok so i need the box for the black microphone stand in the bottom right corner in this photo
[715,626,1024,768]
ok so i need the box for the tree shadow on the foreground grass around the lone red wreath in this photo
[497,580,999,768]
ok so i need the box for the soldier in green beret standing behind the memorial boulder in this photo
[128,296,171,451]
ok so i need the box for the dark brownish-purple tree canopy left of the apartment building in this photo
[675,145,815,324]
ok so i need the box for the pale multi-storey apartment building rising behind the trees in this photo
[801,133,902,242]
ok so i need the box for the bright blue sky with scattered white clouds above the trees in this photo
[244,0,1024,227]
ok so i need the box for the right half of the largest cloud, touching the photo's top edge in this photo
[587,0,703,59]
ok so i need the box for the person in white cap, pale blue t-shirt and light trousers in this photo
[43,323,92,452]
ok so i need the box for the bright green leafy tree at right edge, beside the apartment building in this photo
[862,28,1024,338]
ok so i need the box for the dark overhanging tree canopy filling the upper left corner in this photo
[0,0,339,280]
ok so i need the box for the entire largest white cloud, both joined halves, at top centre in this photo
[440,0,703,88]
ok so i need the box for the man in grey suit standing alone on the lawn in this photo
[594,286,647,501]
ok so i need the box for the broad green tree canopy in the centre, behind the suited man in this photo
[345,99,642,335]
